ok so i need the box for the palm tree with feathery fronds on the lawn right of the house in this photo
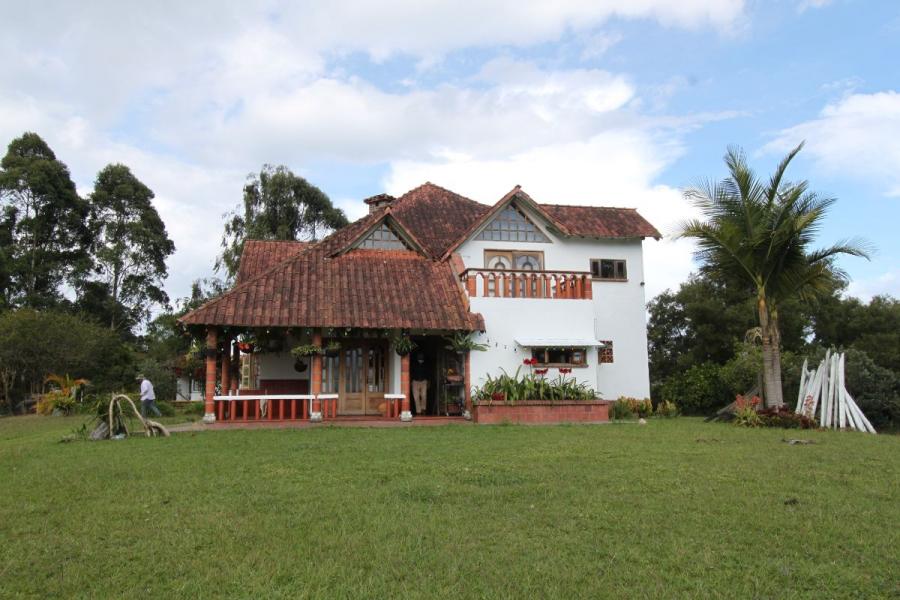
[678,143,868,407]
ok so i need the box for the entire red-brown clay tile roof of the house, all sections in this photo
[181,183,659,331]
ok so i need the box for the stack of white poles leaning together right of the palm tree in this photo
[794,350,875,433]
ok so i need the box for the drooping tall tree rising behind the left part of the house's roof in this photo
[216,165,347,278]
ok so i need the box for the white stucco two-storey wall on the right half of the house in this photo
[459,204,653,399]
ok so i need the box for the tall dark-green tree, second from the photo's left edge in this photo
[90,164,175,329]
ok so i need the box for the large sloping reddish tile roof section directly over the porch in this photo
[182,240,481,331]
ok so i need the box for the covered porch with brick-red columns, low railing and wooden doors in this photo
[203,326,471,424]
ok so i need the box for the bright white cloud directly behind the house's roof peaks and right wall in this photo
[385,131,695,300]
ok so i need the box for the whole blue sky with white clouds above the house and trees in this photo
[0,0,900,308]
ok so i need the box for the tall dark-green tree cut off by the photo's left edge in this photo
[0,133,90,307]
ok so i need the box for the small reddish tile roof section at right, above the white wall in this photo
[541,204,662,239]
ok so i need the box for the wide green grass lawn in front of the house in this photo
[0,417,900,599]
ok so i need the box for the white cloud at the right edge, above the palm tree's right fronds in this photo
[766,90,900,196]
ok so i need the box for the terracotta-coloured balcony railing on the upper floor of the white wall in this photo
[460,269,593,300]
